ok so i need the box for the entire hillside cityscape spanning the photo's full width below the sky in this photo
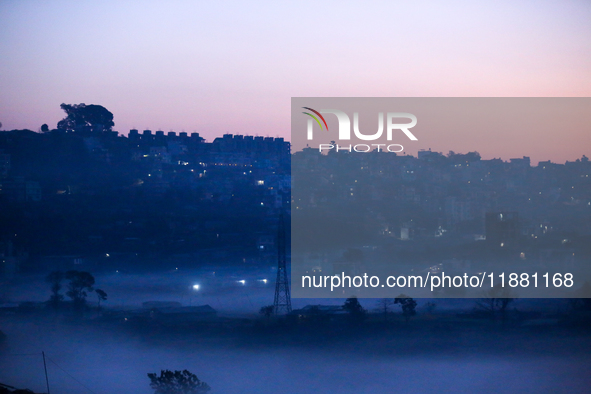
[0,121,591,284]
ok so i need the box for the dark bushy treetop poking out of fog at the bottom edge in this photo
[148,369,211,394]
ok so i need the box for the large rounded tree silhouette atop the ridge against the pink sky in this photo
[57,103,115,131]
